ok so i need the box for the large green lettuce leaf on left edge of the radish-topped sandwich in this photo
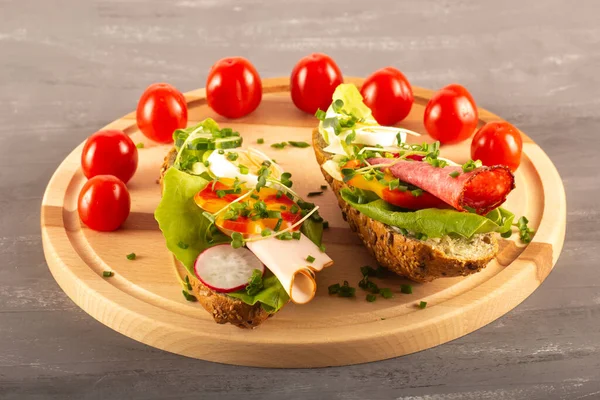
[154,168,231,274]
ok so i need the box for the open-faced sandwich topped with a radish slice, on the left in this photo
[155,119,332,328]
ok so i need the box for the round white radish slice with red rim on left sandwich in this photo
[194,244,265,293]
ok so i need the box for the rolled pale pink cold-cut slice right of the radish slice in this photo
[246,235,333,304]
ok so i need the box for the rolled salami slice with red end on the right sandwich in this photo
[368,158,515,215]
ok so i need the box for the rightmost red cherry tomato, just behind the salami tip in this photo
[471,121,523,172]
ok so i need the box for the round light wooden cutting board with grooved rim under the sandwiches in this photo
[41,78,566,368]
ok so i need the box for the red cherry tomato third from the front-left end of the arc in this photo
[136,83,187,143]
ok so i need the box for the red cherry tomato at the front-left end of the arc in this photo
[77,175,131,232]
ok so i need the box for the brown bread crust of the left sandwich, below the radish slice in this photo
[159,148,272,328]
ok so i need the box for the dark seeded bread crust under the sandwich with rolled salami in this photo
[312,129,498,282]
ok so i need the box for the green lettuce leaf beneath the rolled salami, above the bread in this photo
[341,188,514,238]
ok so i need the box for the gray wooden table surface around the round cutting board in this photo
[0,0,600,400]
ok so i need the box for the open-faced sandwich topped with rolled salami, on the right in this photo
[313,84,515,282]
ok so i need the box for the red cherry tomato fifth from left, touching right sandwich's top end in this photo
[290,53,344,114]
